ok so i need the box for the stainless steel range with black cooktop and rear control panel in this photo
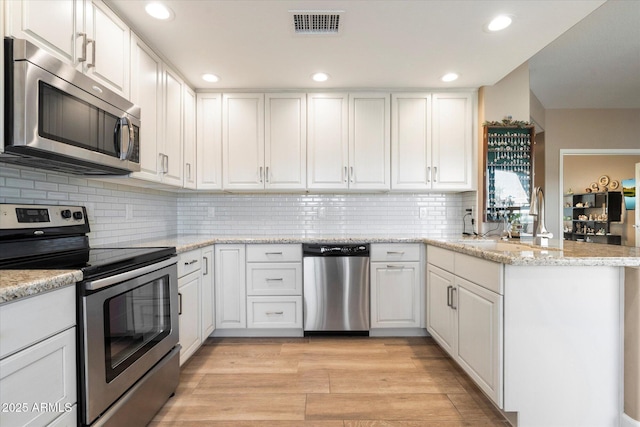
[0,204,180,426]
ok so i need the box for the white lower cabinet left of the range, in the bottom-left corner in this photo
[0,286,77,426]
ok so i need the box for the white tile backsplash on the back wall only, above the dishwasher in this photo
[178,192,476,238]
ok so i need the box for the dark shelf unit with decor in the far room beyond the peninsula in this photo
[563,191,622,245]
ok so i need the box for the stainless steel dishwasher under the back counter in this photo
[302,243,369,334]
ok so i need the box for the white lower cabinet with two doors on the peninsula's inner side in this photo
[427,246,504,407]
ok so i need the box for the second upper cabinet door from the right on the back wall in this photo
[391,93,431,190]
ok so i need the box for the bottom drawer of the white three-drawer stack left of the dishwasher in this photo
[247,296,302,328]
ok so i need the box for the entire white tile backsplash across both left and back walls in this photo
[0,163,476,246]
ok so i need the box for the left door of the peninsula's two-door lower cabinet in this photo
[426,264,456,357]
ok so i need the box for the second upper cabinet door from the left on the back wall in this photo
[222,93,264,190]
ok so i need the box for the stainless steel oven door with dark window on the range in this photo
[79,258,178,425]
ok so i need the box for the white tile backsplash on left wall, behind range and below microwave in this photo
[0,163,177,246]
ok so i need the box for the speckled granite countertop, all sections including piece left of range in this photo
[0,235,640,304]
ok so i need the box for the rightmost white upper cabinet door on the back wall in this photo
[431,93,475,190]
